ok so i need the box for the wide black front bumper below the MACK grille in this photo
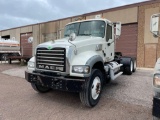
[25,71,85,92]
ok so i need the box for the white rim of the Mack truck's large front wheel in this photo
[91,77,101,100]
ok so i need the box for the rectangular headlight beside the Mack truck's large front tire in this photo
[72,66,90,74]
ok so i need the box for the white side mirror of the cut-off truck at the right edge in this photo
[150,14,159,37]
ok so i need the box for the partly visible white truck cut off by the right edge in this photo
[150,13,160,120]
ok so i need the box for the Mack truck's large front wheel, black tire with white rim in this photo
[79,69,104,107]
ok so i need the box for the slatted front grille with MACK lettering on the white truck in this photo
[36,48,66,72]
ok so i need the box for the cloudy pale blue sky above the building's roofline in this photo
[0,0,146,30]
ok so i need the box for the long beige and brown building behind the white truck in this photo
[0,0,160,68]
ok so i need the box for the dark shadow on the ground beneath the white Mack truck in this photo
[31,82,118,111]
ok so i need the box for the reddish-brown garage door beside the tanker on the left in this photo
[20,33,32,57]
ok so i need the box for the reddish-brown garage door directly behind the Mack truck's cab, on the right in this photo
[116,24,138,57]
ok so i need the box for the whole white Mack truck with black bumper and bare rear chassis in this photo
[25,18,136,107]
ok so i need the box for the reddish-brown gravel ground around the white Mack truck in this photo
[0,63,153,120]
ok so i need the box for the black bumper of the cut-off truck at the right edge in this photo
[152,97,160,118]
